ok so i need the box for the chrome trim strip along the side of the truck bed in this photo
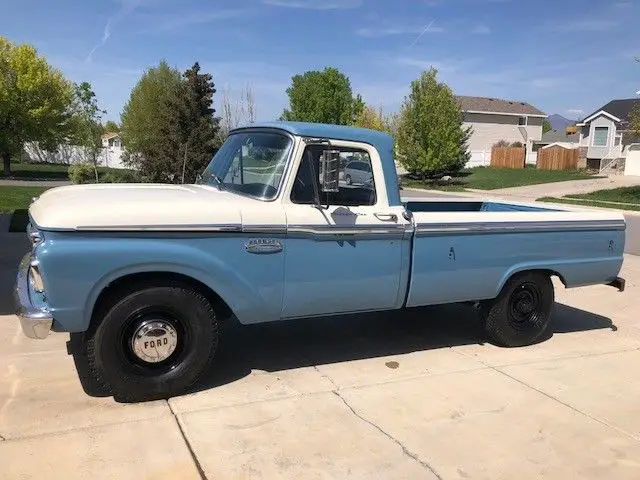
[416,220,626,237]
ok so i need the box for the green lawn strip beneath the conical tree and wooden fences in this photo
[402,167,598,191]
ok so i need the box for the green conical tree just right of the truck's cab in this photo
[396,68,471,178]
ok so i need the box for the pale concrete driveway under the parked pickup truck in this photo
[0,237,640,480]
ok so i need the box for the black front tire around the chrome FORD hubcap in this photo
[85,283,219,402]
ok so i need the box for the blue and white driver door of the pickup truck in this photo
[283,142,408,318]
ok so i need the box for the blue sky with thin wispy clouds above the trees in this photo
[0,0,640,124]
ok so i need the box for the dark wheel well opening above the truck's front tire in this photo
[91,272,233,324]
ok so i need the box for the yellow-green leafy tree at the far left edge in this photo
[0,36,73,176]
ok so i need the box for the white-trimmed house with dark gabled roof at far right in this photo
[577,98,640,173]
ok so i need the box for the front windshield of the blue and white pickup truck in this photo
[199,132,293,200]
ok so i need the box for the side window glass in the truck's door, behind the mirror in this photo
[291,145,376,207]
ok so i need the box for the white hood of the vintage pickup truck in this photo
[29,184,250,230]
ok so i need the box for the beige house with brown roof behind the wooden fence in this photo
[456,96,547,166]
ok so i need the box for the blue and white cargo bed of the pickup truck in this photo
[404,199,625,307]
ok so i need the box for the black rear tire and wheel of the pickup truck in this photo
[485,271,555,347]
